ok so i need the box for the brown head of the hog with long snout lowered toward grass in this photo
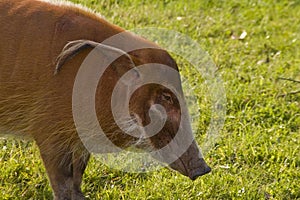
[121,49,211,180]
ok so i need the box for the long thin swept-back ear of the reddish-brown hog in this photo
[55,40,140,82]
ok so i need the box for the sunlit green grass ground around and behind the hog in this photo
[0,0,300,199]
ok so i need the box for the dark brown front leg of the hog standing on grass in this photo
[37,138,90,200]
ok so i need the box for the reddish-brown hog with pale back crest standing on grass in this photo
[0,0,210,199]
